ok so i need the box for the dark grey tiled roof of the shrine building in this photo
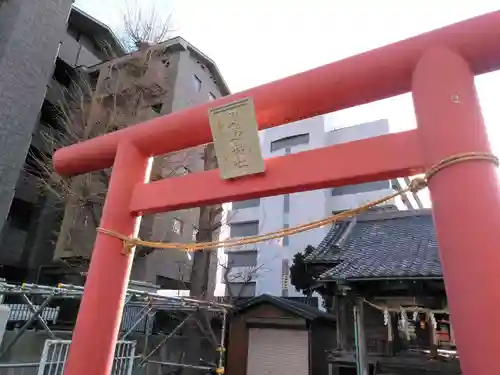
[306,210,442,280]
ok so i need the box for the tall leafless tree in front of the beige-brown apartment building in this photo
[31,7,191,280]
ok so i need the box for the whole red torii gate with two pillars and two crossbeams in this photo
[54,11,500,375]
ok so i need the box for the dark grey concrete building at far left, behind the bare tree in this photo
[0,0,102,280]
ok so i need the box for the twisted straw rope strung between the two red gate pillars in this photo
[97,152,498,253]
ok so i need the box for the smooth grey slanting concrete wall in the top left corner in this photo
[0,0,73,264]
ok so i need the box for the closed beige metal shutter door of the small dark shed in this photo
[246,328,309,375]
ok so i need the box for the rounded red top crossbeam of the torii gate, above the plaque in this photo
[54,12,500,175]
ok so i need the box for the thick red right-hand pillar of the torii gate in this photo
[412,47,500,375]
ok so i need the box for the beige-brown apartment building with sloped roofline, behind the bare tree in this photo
[81,37,229,290]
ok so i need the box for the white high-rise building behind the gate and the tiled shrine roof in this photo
[225,116,421,297]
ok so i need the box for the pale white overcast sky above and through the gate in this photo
[76,0,500,206]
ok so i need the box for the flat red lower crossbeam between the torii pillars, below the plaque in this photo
[130,130,424,213]
